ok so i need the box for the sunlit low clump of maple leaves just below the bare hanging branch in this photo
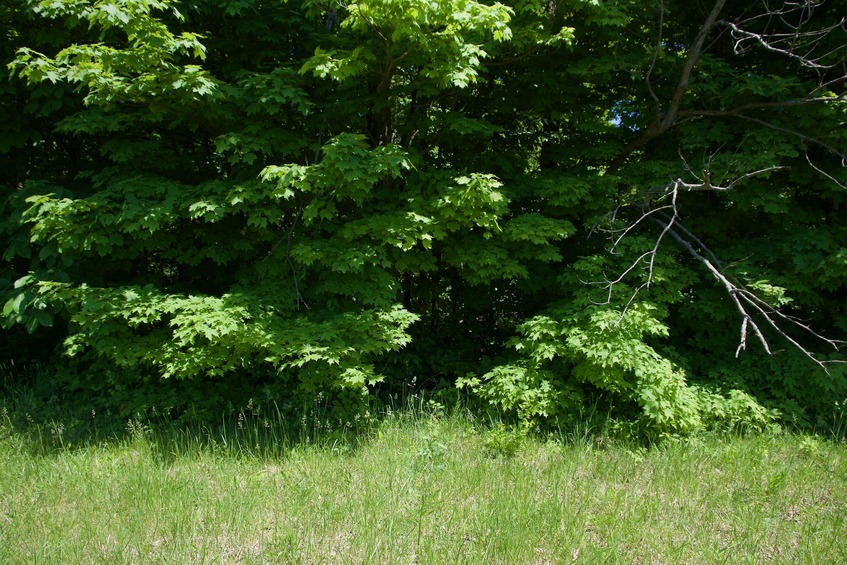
[463,305,701,432]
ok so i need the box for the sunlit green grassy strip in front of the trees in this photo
[0,398,847,564]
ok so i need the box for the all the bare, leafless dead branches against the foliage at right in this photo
[592,0,847,370]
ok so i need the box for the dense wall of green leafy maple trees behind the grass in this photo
[0,0,847,432]
